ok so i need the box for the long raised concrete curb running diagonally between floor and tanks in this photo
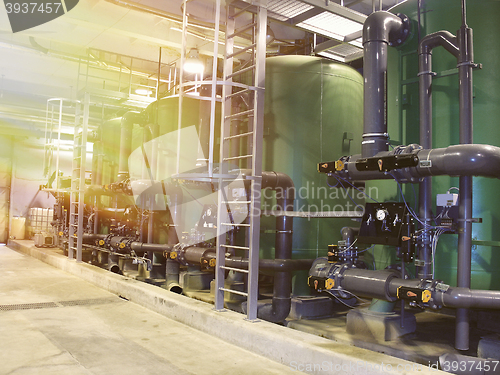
[9,241,444,375]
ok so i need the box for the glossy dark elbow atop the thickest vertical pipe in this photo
[363,11,410,46]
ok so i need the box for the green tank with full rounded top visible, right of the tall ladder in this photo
[261,56,363,294]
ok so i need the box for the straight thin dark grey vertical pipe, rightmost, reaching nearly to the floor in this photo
[455,19,473,350]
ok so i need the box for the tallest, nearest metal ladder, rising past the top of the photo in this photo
[215,0,267,321]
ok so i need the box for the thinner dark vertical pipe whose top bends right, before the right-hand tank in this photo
[417,31,458,279]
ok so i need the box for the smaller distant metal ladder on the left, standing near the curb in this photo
[68,92,90,262]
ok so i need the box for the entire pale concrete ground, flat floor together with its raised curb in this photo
[5,240,443,375]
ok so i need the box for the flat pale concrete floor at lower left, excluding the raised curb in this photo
[0,247,297,375]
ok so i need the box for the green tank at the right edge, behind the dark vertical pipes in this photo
[387,0,500,289]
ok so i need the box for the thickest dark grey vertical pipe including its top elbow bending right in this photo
[361,11,409,157]
